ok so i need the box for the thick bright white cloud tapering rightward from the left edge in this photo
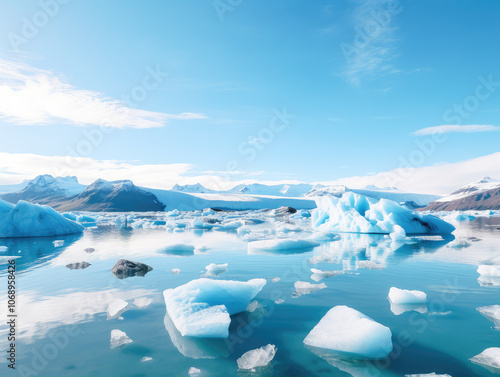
[0,59,206,128]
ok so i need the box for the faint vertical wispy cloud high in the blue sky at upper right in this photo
[340,0,402,86]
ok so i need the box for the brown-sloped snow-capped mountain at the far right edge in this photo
[424,177,500,211]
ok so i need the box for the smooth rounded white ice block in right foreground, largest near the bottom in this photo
[304,306,392,359]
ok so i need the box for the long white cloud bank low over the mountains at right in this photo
[323,152,500,195]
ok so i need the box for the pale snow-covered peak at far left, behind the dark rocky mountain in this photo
[0,174,86,204]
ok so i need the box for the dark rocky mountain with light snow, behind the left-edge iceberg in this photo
[54,179,165,212]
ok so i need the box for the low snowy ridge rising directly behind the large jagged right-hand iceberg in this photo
[306,184,440,209]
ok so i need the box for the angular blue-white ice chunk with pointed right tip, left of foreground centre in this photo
[163,279,266,338]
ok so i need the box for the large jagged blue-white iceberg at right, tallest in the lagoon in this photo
[312,192,455,234]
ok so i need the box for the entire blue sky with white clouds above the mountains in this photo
[0,0,500,194]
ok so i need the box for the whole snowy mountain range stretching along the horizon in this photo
[0,175,500,212]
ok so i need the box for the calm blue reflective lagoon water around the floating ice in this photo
[0,212,500,377]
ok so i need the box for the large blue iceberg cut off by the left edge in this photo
[0,200,85,238]
